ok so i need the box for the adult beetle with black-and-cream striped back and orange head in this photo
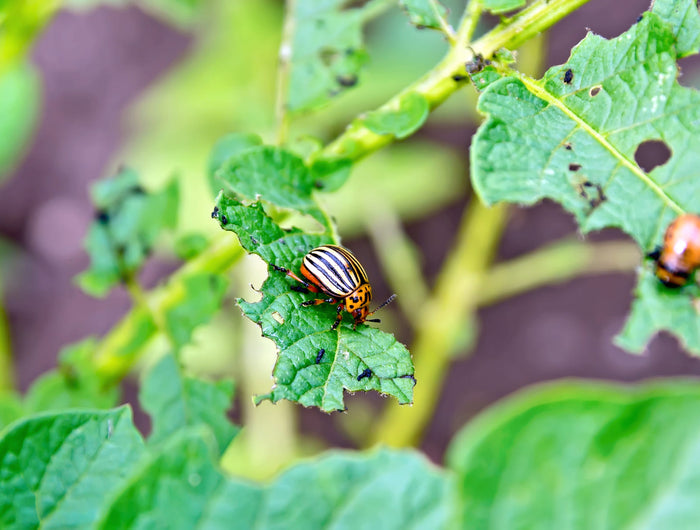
[273,245,396,329]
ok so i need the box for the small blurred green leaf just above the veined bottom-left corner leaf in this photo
[25,339,120,412]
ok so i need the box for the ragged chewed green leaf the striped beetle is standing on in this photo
[215,193,415,411]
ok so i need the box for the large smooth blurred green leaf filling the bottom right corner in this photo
[447,381,700,530]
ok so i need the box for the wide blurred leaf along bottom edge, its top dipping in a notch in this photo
[99,433,453,530]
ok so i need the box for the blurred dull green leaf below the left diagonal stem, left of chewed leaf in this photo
[140,355,239,454]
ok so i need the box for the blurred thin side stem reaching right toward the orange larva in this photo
[477,239,641,307]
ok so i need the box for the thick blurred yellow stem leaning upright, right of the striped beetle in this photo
[371,198,506,447]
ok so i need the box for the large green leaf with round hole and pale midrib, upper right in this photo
[471,0,700,353]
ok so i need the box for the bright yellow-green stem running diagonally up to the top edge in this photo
[315,0,588,161]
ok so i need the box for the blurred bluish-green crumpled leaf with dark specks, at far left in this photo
[77,169,179,296]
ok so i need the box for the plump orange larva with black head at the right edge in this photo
[649,214,700,287]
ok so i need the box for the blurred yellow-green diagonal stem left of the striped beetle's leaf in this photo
[95,233,244,384]
